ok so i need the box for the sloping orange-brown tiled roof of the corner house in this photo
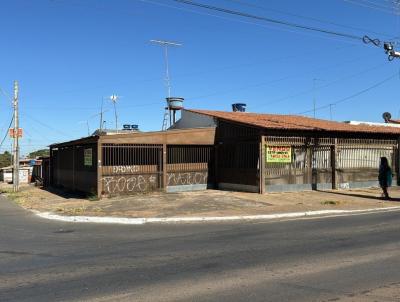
[185,109,400,135]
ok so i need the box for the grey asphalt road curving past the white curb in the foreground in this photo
[0,196,400,302]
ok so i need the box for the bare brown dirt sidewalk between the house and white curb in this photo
[0,184,400,218]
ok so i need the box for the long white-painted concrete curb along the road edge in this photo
[33,206,400,225]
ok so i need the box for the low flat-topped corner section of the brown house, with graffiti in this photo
[50,128,215,196]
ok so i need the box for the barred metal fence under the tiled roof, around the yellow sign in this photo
[264,137,399,192]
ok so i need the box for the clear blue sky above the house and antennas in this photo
[0,0,400,154]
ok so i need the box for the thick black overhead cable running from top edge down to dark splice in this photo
[172,0,362,40]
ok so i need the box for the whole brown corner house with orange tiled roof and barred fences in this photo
[50,110,400,196]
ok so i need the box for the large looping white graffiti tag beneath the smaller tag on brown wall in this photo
[101,174,159,194]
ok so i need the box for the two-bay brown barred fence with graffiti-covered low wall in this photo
[100,144,214,195]
